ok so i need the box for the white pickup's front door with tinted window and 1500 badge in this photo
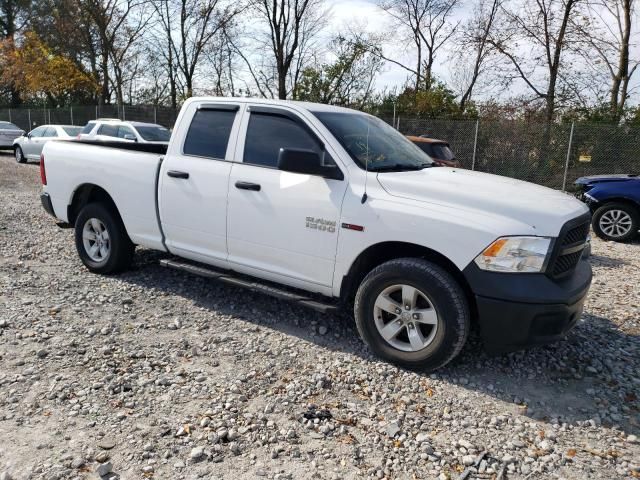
[228,106,347,291]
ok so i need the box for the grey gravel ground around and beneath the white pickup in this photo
[0,156,640,480]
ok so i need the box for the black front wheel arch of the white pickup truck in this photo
[340,241,477,318]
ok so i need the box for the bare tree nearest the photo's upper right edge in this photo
[577,0,640,121]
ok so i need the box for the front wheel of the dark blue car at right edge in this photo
[591,202,640,242]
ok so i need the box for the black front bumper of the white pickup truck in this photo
[463,260,592,352]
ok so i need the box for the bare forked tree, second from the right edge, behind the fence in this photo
[489,0,583,122]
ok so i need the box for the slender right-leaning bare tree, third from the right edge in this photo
[455,0,504,112]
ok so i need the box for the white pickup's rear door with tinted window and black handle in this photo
[159,103,240,265]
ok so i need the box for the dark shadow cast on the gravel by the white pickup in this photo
[119,250,640,435]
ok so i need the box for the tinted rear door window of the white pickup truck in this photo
[183,110,236,159]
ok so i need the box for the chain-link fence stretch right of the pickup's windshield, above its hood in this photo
[384,118,640,190]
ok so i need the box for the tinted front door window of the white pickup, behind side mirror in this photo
[242,113,322,168]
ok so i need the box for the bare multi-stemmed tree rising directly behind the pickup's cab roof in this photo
[252,0,327,99]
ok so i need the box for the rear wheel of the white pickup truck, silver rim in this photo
[75,203,135,274]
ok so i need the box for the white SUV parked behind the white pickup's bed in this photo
[78,119,171,144]
